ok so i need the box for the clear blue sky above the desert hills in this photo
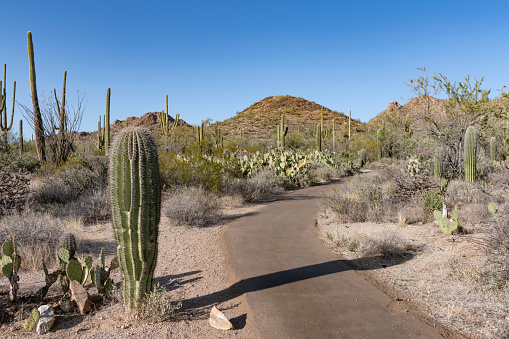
[0,0,509,131]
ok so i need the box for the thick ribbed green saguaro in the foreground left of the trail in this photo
[109,127,161,309]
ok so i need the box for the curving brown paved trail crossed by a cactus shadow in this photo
[224,184,442,339]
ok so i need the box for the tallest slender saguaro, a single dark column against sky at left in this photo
[27,31,46,161]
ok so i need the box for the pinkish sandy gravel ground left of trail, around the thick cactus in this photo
[0,204,270,338]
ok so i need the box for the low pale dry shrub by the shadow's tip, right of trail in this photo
[359,229,406,259]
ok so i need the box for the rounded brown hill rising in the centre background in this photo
[212,95,365,140]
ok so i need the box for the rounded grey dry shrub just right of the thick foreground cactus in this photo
[163,187,219,226]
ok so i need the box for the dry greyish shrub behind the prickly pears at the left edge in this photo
[0,209,65,271]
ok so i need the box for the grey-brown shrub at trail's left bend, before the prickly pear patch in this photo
[225,169,279,202]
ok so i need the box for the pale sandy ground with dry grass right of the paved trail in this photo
[316,213,509,338]
